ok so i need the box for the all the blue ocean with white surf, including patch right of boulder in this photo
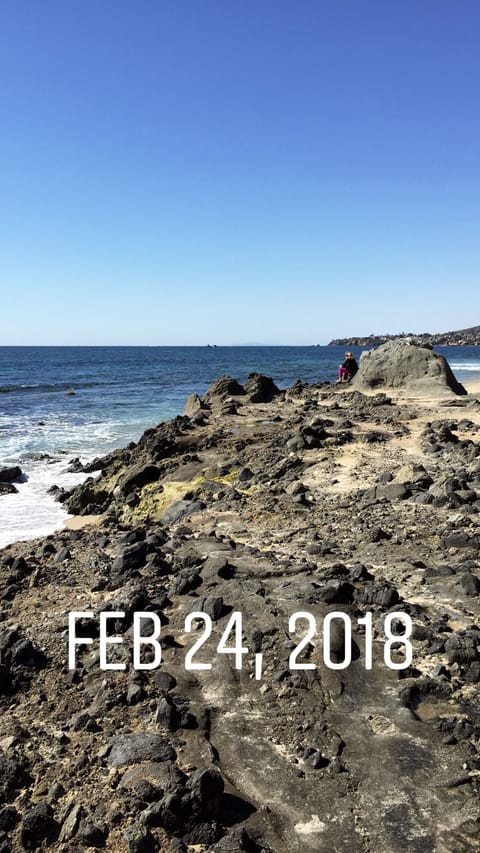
[0,346,480,546]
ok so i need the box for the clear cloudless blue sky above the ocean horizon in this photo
[0,0,480,345]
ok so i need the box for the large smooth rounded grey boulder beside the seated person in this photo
[349,340,467,394]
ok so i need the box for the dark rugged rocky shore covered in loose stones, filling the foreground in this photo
[0,356,480,853]
